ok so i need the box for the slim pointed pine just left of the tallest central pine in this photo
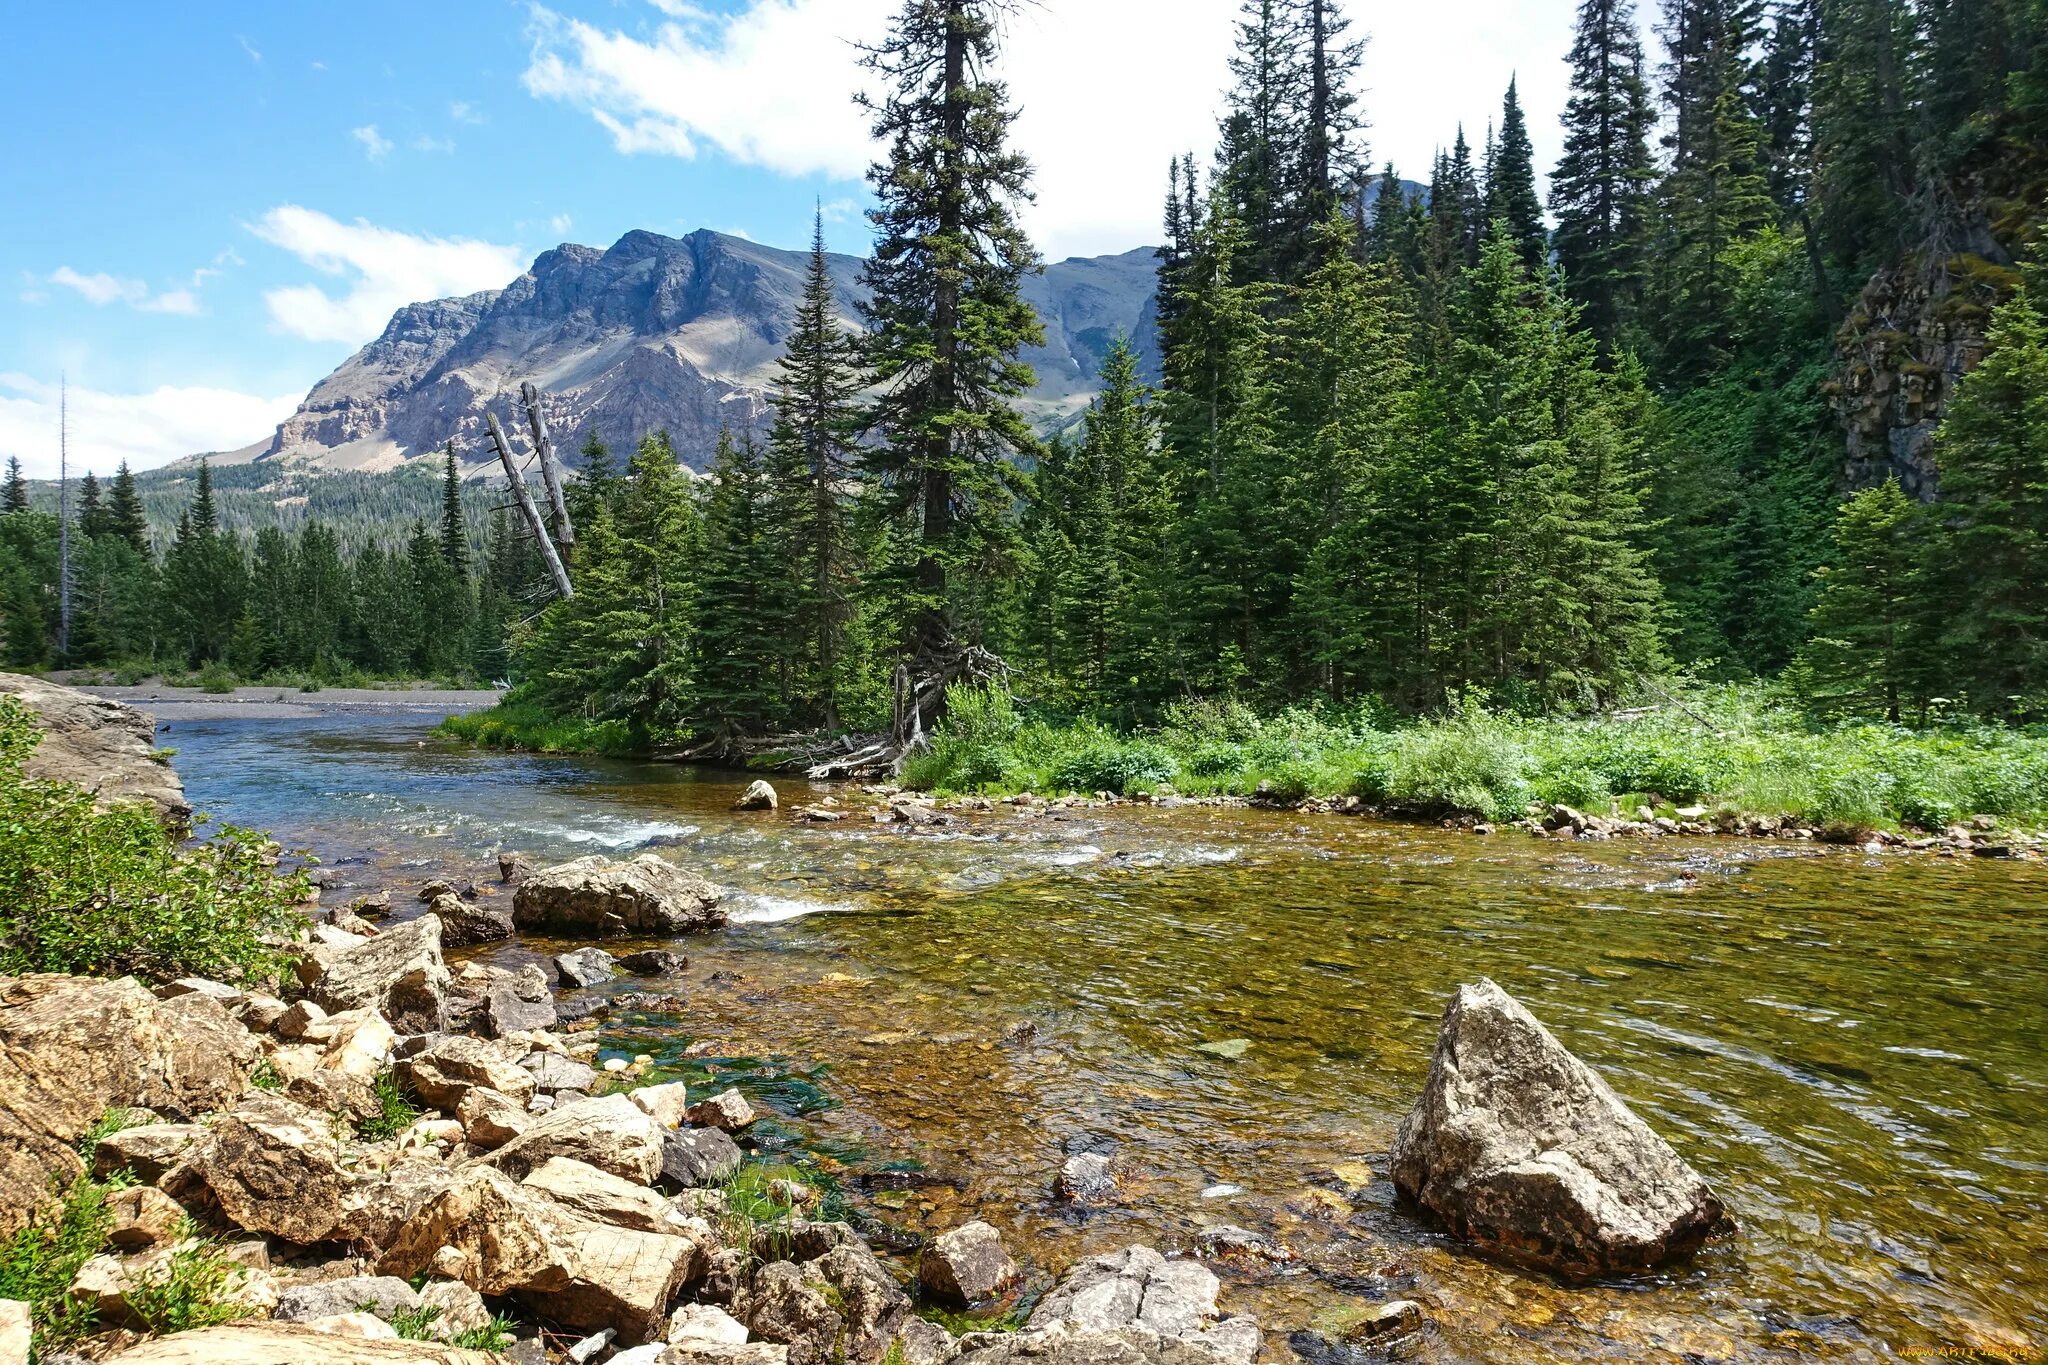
[766,215,864,729]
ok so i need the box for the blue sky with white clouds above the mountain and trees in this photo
[0,0,1575,473]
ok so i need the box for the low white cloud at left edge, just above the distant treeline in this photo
[0,372,301,479]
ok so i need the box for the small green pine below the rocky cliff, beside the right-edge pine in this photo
[1790,479,1929,722]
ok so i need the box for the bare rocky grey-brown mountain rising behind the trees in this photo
[252,231,1157,471]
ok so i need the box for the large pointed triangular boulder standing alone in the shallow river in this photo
[1393,978,1729,1275]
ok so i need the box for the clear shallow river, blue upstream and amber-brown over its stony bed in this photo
[156,704,2048,1361]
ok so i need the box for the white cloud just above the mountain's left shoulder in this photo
[250,205,526,344]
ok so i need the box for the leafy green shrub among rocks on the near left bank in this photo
[0,698,307,980]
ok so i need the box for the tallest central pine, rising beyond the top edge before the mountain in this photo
[862,0,1042,677]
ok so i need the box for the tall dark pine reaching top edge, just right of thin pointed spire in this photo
[1550,0,1657,350]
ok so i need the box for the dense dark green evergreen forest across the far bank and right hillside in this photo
[8,0,2048,751]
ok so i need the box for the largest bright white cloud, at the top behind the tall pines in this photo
[524,0,1577,258]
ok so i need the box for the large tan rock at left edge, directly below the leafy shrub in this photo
[0,976,258,1236]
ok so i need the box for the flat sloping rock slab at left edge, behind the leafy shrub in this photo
[0,673,193,829]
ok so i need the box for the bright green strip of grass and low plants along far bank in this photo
[903,686,2048,831]
